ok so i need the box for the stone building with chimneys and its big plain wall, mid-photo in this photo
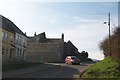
[26,32,64,62]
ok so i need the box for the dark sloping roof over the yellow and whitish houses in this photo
[2,16,26,36]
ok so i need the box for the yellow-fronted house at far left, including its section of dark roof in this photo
[0,16,15,63]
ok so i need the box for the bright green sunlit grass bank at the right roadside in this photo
[82,57,120,78]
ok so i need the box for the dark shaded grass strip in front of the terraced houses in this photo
[2,62,43,71]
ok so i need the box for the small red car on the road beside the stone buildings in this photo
[65,56,80,64]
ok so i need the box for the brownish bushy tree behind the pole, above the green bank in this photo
[100,27,120,59]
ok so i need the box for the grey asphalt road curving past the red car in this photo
[2,63,92,78]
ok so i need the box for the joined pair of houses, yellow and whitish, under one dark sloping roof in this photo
[0,15,27,63]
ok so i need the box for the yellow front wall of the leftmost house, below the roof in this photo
[2,29,14,63]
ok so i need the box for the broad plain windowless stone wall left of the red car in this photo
[26,43,63,62]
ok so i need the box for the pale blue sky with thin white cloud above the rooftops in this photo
[0,0,118,60]
